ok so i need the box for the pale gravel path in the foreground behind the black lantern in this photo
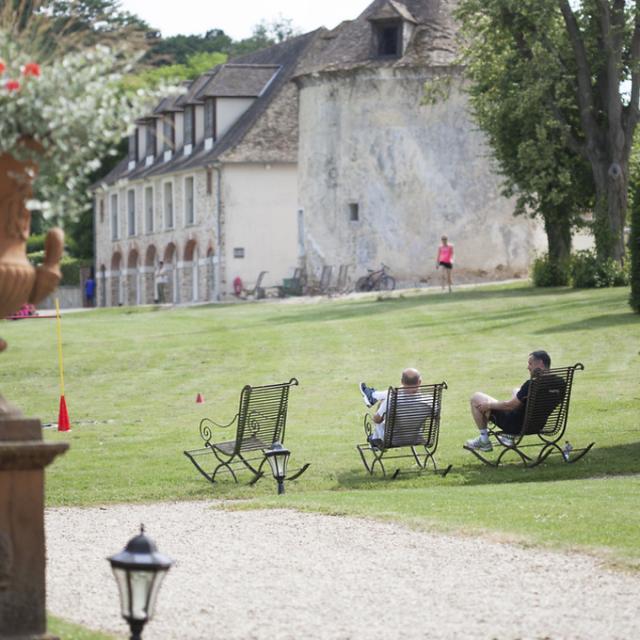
[46,502,640,640]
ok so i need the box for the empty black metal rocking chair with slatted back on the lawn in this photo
[184,378,309,484]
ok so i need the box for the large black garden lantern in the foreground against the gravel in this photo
[107,525,173,640]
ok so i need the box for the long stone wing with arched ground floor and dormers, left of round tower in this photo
[94,33,315,305]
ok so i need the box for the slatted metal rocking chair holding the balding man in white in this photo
[356,382,451,478]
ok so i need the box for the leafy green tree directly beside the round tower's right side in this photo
[459,3,594,272]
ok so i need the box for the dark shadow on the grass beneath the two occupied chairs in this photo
[337,442,640,490]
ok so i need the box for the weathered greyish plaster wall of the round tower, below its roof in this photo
[299,68,544,281]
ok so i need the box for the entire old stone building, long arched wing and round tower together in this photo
[95,0,545,305]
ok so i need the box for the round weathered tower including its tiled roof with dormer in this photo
[295,0,544,282]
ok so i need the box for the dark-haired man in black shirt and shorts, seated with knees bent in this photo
[465,351,551,451]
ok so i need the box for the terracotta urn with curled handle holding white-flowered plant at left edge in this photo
[0,140,64,419]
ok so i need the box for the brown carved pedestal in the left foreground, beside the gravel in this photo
[0,417,69,640]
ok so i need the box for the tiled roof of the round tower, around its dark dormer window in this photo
[296,0,457,76]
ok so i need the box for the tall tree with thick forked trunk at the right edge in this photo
[460,0,640,262]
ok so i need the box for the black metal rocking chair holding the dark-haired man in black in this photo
[464,362,595,467]
